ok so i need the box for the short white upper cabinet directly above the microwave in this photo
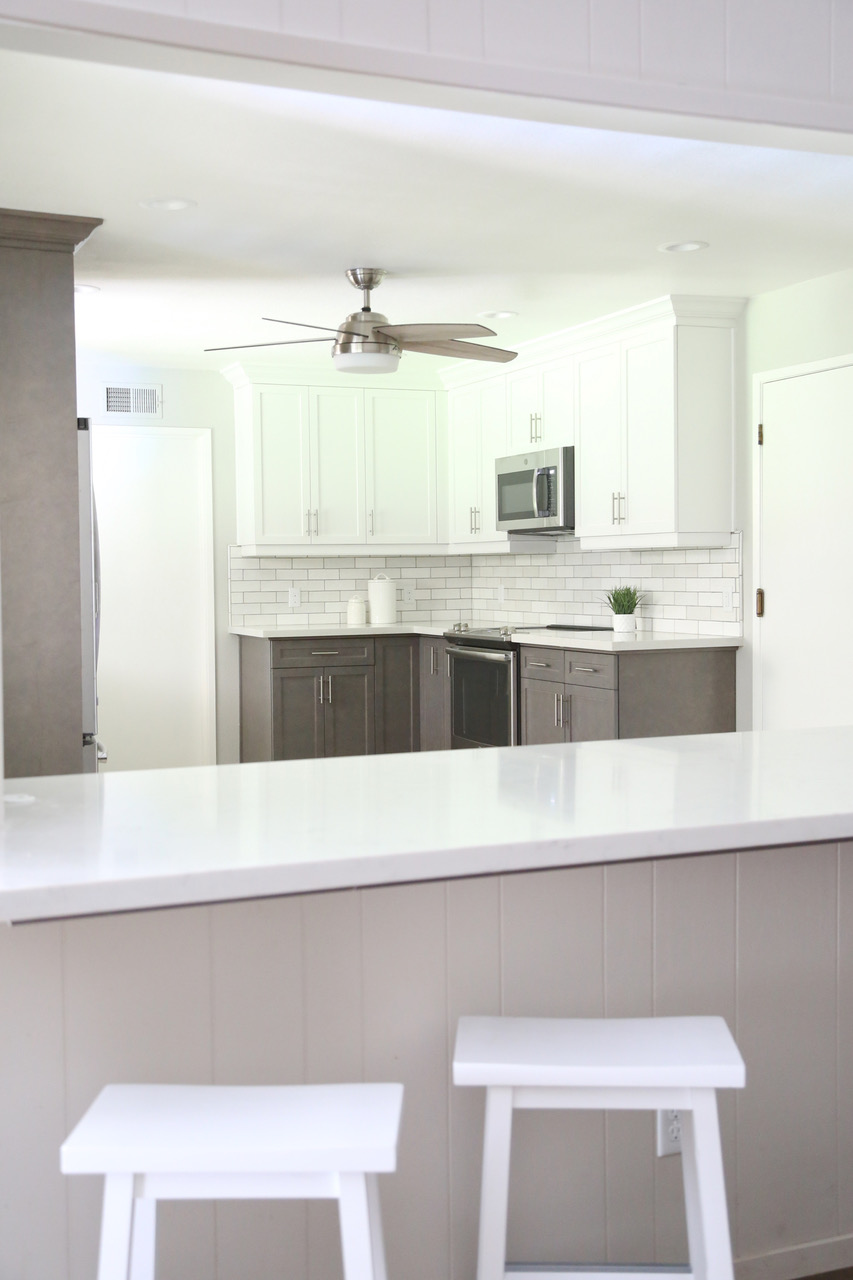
[506,360,575,453]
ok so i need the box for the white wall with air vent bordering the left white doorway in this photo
[77,351,240,764]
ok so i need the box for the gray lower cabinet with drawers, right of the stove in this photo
[520,645,735,745]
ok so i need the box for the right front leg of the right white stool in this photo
[681,1089,734,1280]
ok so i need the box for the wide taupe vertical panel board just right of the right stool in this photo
[738,845,838,1254]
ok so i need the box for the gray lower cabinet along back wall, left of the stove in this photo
[240,636,419,762]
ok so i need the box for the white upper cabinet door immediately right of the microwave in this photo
[575,347,622,535]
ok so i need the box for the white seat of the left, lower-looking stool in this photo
[60,1084,403,1174]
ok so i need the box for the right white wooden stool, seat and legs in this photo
[453,1018,745,1280]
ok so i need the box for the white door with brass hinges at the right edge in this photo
[754,358,853,728]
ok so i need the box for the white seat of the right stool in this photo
[453,1018,745,1089]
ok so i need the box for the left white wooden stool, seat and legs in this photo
[60,1084,403,1280]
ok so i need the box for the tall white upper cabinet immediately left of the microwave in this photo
[448,378,507,543]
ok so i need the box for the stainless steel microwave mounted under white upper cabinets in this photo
[494,445,575,534]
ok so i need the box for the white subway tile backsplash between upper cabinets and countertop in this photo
[228,535,743,636]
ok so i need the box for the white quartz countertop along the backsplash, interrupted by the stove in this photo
[232,622,743,653]
